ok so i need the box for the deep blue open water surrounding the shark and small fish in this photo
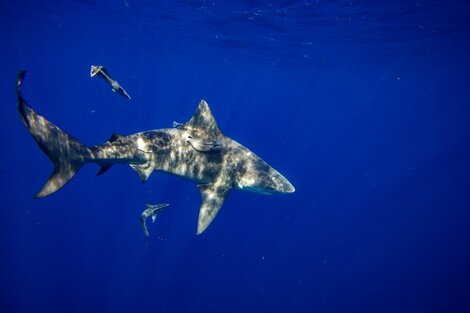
[0,0,470,312]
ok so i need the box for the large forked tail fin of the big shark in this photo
[16,71,91,198]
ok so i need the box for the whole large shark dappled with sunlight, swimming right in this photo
[17,71,295,234]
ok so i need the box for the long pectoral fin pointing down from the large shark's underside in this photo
[197,184,230,235]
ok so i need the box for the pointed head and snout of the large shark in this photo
[237,159,295,195]
